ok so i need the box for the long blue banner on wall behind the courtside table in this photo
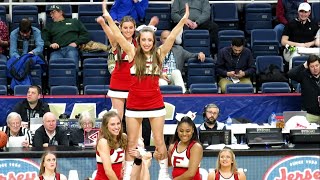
[0,93,301,126]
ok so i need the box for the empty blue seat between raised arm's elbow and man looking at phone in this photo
[182,30,211,57]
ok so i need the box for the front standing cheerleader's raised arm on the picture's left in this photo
[102,0,135,62]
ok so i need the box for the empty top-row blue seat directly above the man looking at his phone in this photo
[212,3,239,30]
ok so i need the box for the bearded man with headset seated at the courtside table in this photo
[197,103,237,144]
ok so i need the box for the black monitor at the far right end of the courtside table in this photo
[289,129,320,144]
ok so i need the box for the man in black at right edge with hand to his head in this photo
[288,55,320,124]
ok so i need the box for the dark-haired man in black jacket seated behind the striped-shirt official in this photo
[12,86,50,127]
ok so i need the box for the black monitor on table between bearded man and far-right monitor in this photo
[246,128,284,146]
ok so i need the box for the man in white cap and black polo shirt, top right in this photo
[281,2,319,69]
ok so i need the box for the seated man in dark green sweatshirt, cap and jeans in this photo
[42,5,90,69]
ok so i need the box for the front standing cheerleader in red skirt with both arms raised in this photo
[102,2,189,179]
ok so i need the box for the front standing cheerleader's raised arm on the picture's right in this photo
[159,3,189,61]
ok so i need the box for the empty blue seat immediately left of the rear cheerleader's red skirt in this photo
[83,58,111,86]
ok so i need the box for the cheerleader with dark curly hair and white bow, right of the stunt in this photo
[168,116,203,180]
